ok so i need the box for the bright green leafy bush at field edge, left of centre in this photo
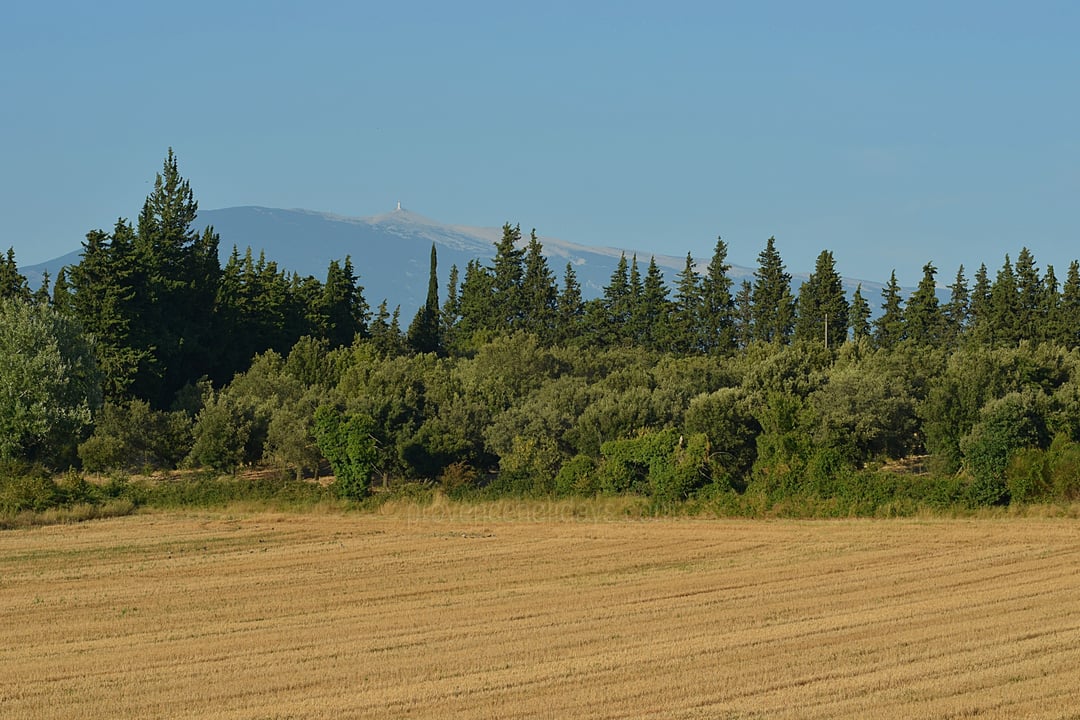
[314,405,378,500]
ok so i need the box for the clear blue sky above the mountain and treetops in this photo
[0,0,1080,286]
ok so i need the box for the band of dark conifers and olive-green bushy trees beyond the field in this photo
[0,150,1080,511]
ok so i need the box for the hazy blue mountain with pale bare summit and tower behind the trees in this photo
[22,206,882,317]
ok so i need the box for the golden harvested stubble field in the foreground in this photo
[0,511,1080,720]
